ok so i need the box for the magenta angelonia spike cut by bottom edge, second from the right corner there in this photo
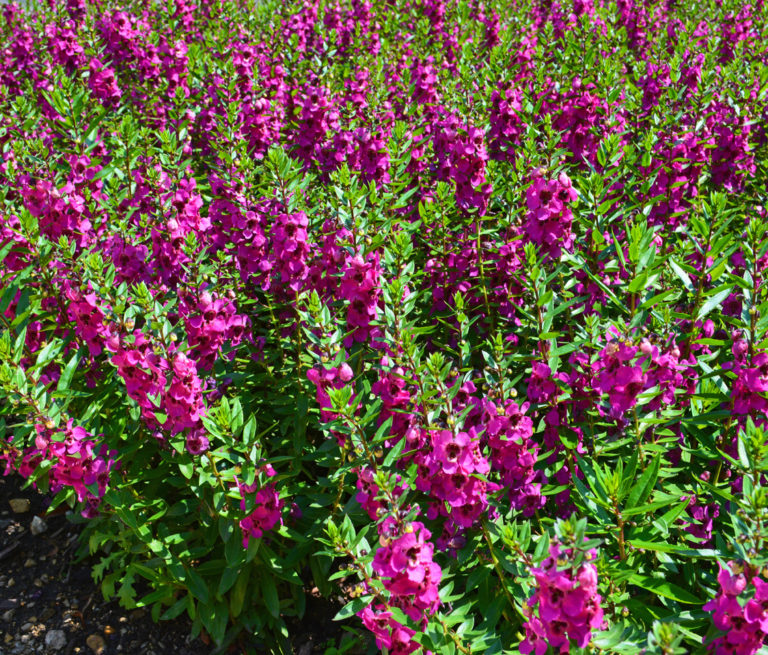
[520,539,603,655]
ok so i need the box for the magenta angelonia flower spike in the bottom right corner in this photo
[703,561,768,655]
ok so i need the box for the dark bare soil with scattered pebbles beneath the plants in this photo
[0,475,359,655]
